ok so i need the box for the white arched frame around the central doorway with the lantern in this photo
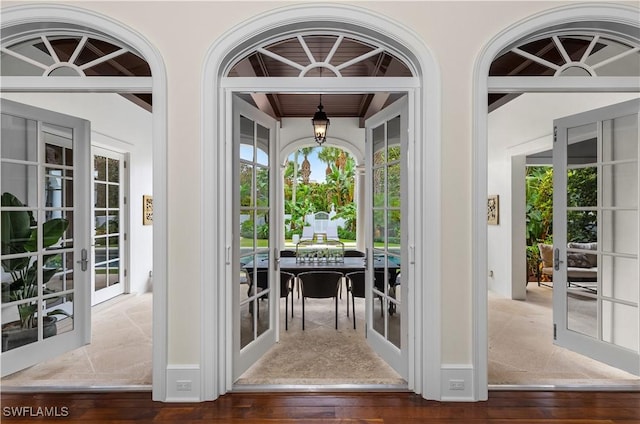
[200,4,441,400]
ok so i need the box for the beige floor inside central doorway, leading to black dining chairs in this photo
[237,292,406,385]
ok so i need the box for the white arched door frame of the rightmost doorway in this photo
[471,4,640,400]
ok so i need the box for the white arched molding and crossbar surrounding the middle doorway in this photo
[202,6,440,399]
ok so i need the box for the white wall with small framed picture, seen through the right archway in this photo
[488,93,638,299]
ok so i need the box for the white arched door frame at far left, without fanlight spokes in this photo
[0,4,169,401]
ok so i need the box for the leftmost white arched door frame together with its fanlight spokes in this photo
[2,5,168,400]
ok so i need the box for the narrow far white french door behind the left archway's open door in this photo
[91,147,128,306]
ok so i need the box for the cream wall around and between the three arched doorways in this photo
[3,1,635,390]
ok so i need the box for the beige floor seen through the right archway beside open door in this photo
[489,283,640,387]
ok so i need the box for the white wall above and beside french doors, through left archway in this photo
[2,93,153,293]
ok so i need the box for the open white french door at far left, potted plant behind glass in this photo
[0,99,91,376]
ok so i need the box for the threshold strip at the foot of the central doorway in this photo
[231,384,411,393]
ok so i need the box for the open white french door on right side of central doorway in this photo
[365,96,408,379]
